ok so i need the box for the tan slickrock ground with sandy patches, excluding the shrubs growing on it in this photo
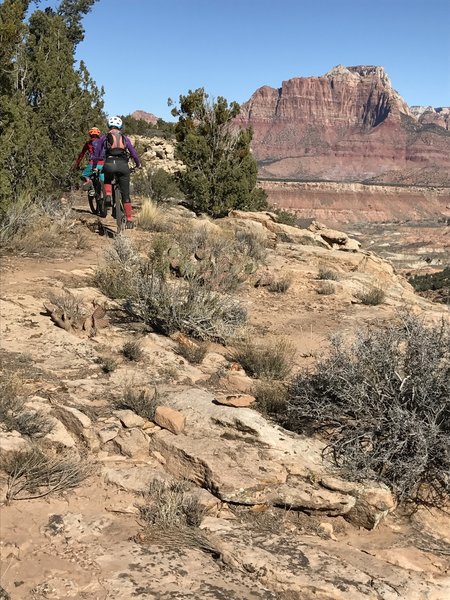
[0,200,450,600]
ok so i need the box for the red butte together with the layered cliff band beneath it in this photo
[239,65,450,221]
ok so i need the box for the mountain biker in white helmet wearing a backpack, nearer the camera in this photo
[94,117,141,229]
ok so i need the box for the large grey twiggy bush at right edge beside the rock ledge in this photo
[280,314,450,504]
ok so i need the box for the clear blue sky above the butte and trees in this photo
[66,0,450,120]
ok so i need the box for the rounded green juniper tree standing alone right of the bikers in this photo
[169,88,267,217]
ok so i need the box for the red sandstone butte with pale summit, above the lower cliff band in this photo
[239,65,450,185]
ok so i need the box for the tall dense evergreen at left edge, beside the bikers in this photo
[0,0,104,217]
